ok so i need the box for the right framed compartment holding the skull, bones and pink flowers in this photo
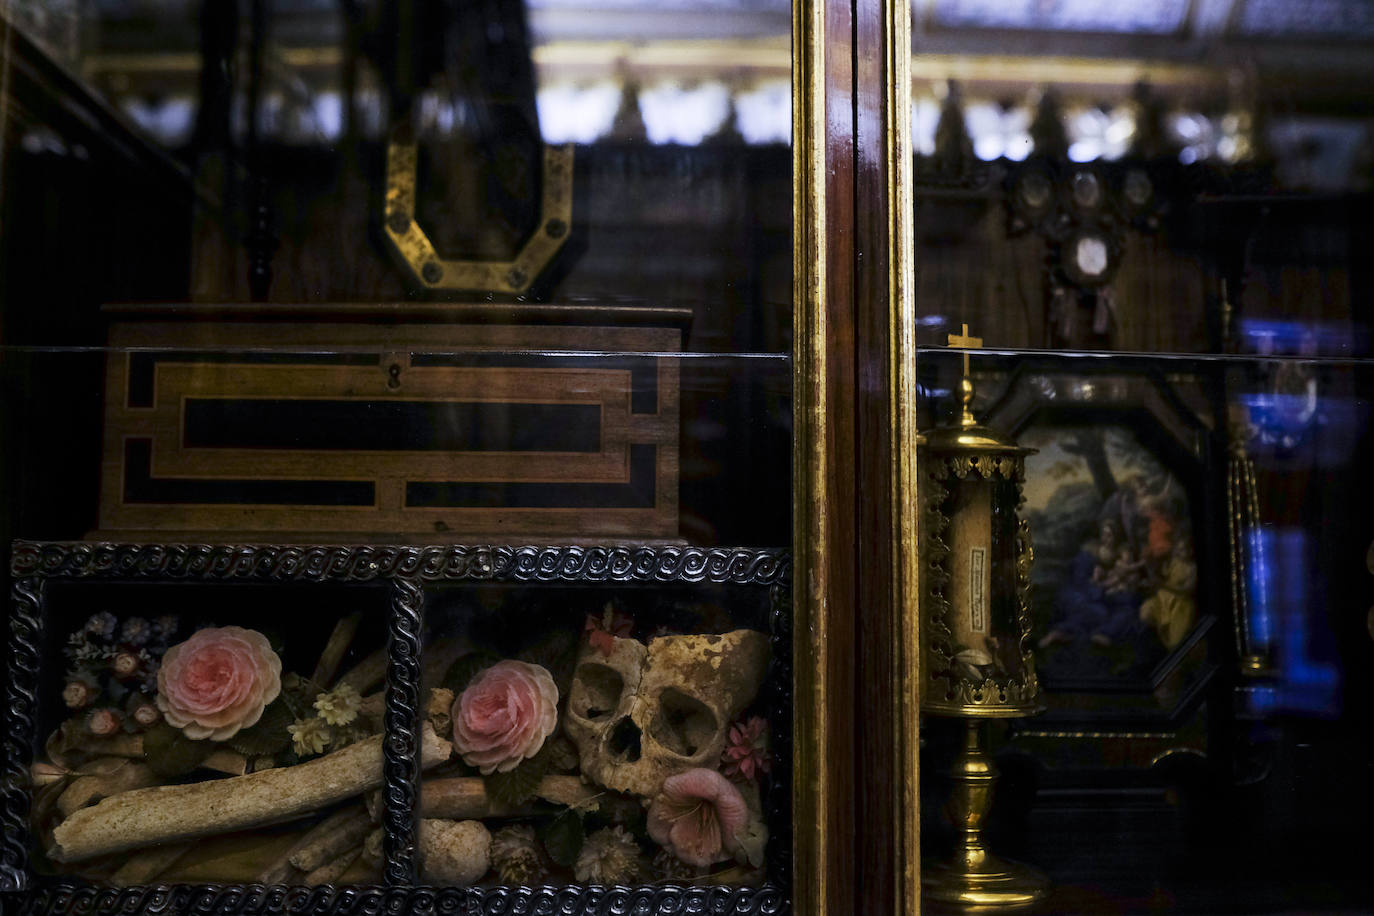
[419,576,790,886]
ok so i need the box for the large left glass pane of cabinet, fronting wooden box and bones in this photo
[0,0,793,912]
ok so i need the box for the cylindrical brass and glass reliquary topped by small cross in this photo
[921,324,1048,911]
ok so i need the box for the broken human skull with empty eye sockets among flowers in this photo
[563,630,768,797]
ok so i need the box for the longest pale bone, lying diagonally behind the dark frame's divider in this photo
[51,728,452,862]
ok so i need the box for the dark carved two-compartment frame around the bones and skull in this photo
[0,541,791,916]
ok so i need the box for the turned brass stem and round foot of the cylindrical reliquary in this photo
[921,718,1050,913]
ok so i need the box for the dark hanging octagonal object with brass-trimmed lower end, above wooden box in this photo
[378,0,573,297]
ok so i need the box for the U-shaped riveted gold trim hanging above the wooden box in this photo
[382,128,573,294]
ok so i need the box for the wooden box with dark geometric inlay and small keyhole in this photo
[96,305,684,540]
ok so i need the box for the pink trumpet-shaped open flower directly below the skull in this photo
[649,768,749,868]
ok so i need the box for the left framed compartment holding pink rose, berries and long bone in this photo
[25,579,387,887]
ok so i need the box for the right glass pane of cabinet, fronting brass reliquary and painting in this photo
[912,1,1374,913]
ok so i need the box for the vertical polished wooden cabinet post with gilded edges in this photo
[793,0,921,916]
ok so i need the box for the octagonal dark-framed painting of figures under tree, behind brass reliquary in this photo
[984,360,1232,786]
